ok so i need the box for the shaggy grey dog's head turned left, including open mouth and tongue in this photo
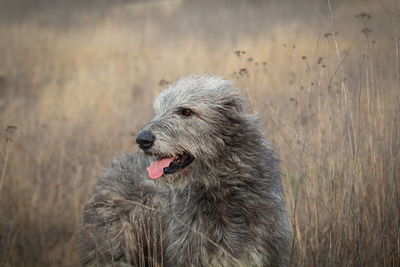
[136,75,244,179]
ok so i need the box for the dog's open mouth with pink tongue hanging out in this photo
[147,152,194,179]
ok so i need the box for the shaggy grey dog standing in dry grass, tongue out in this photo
[79,75,291,266]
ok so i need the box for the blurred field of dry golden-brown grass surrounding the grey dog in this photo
[0,0,400,266]
